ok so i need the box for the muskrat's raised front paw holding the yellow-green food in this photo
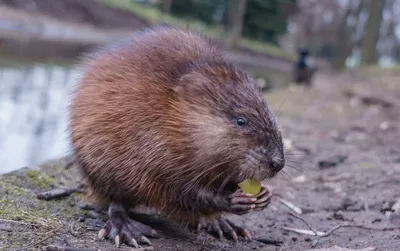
[228,186,272,215]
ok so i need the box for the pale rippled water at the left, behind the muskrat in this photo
[0,64,79,173]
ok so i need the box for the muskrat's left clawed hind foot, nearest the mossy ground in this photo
[99,203,158,248]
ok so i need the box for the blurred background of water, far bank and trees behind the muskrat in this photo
[0,0,400,173]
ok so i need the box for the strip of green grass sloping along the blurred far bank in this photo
[98,0,295,61]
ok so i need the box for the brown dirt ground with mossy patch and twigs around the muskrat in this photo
[0,68,400,251]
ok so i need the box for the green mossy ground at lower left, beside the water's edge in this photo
[0,161,83,250]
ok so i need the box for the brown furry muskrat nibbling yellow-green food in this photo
[70,26,285,247]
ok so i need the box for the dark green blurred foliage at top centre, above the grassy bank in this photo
[167,0,297,42]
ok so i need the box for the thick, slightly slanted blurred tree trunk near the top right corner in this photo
[361,0,384,64]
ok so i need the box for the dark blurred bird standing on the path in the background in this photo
[293,49,317,86]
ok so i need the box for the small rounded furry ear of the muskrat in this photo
[173,72,208,94]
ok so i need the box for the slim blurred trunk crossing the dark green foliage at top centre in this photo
[228,0,247,49]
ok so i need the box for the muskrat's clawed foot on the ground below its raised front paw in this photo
[197,217,251,241]
